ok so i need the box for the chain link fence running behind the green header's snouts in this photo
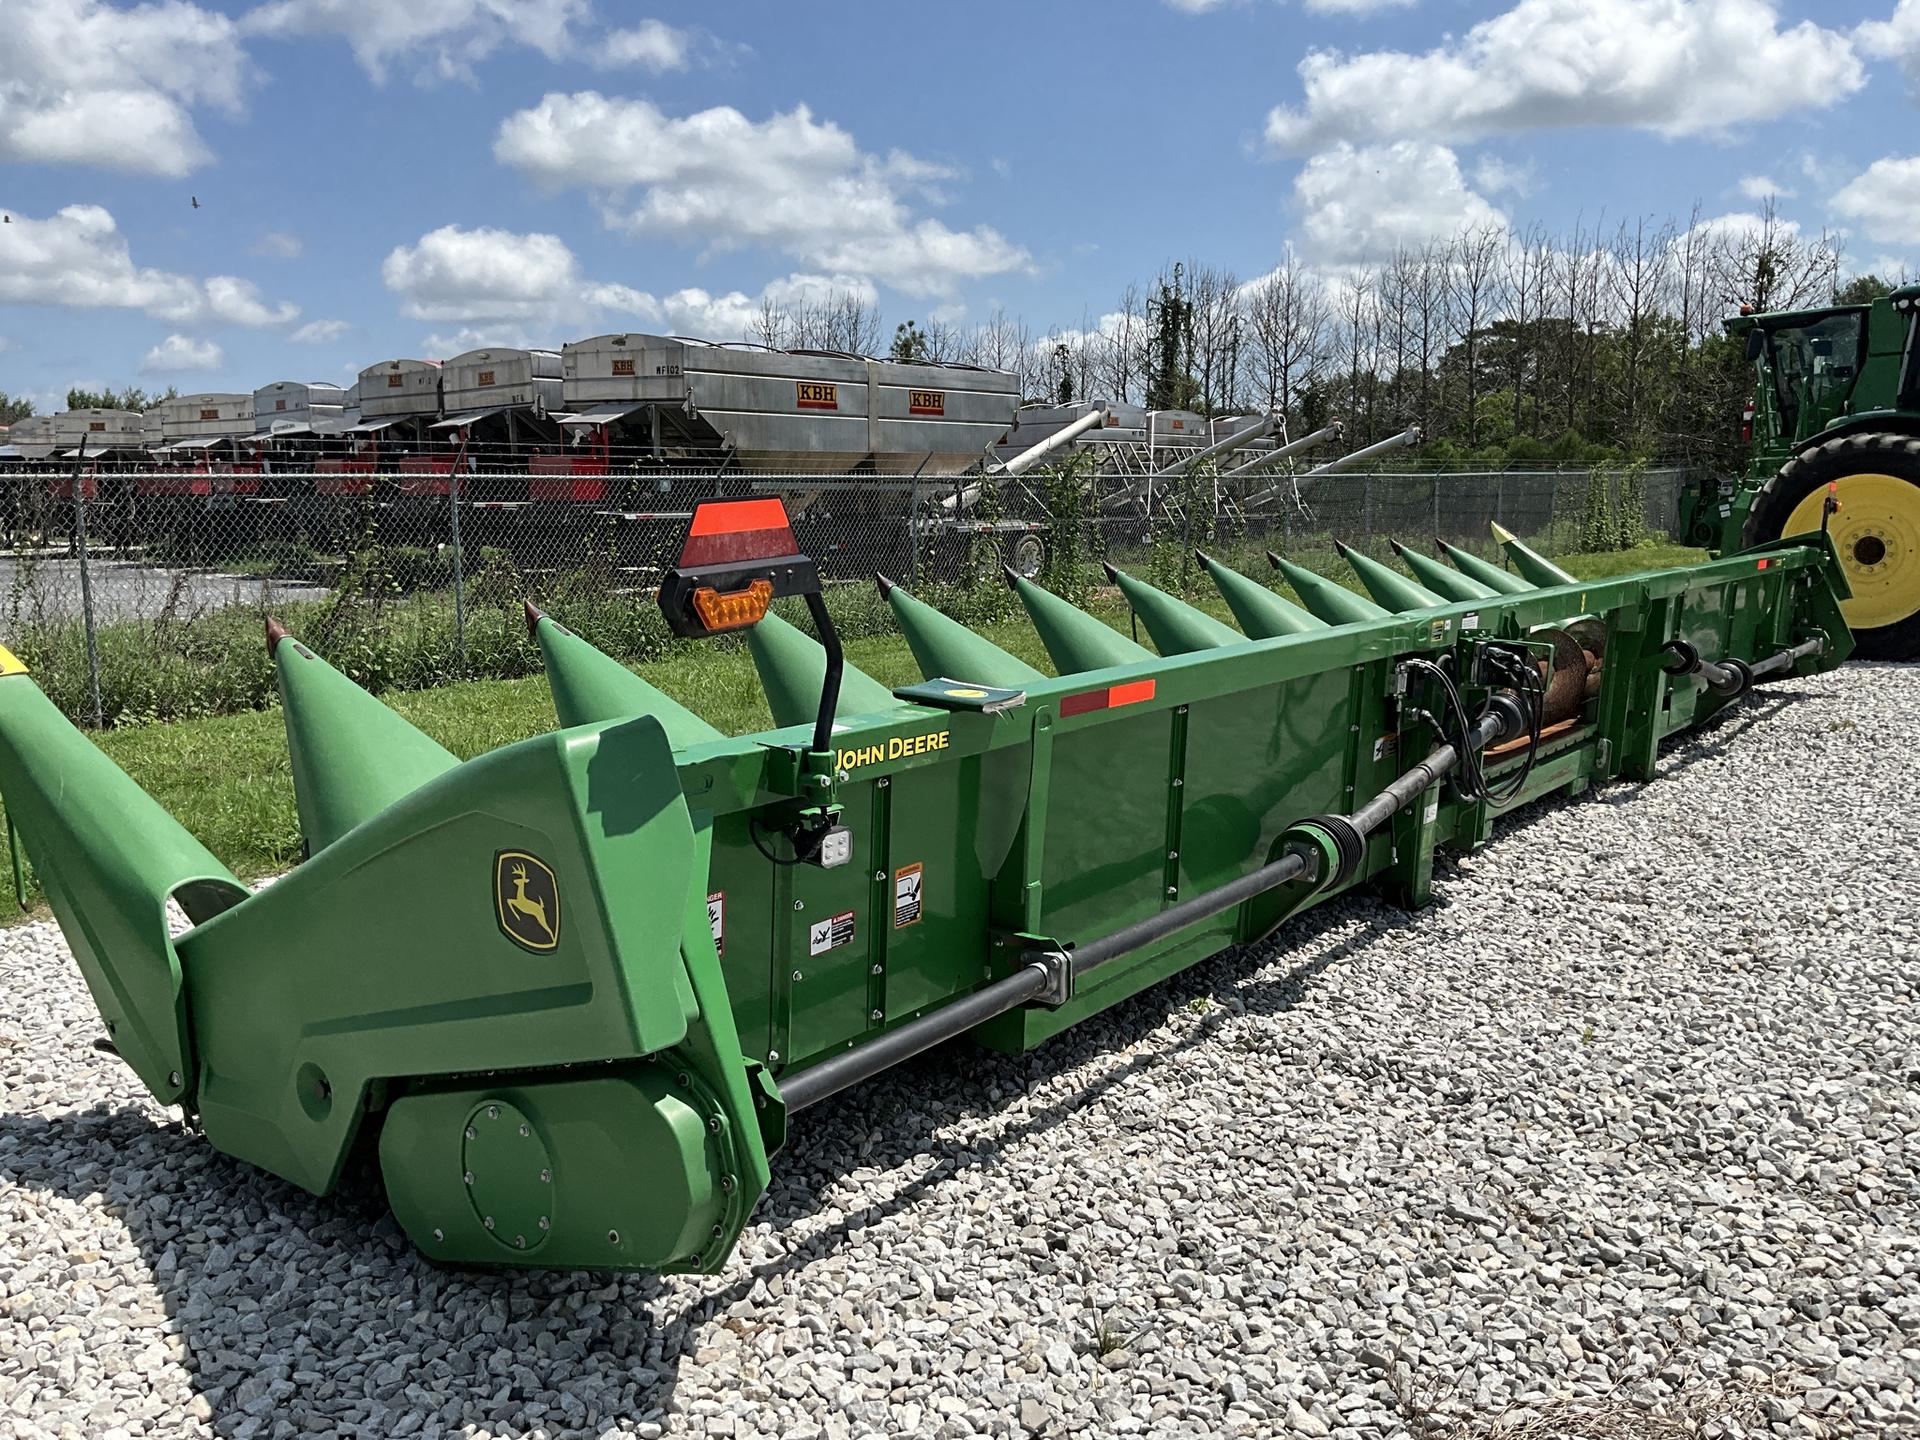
[0,465,1688,726]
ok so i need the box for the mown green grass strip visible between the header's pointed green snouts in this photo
[0,545,1703,908]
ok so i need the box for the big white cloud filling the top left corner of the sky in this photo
[0,0,248,175]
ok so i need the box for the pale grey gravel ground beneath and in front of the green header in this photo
[0,666,1920,1440]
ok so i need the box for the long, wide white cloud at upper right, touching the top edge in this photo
[1267,0,1866,152]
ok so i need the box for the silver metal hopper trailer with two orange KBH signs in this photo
[561,334,1020,474]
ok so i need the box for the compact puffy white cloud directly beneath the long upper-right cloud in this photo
[1294,140,1507,265]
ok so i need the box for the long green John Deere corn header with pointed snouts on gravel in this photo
[0,499,1853,1271]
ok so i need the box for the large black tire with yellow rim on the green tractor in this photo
[1741,432,1920,660]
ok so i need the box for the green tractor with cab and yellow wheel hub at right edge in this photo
[1682,284,1920,660]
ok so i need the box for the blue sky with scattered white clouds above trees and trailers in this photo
[0,0,1920,409]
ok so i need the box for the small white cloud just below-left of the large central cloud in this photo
[380,225,659,324]
